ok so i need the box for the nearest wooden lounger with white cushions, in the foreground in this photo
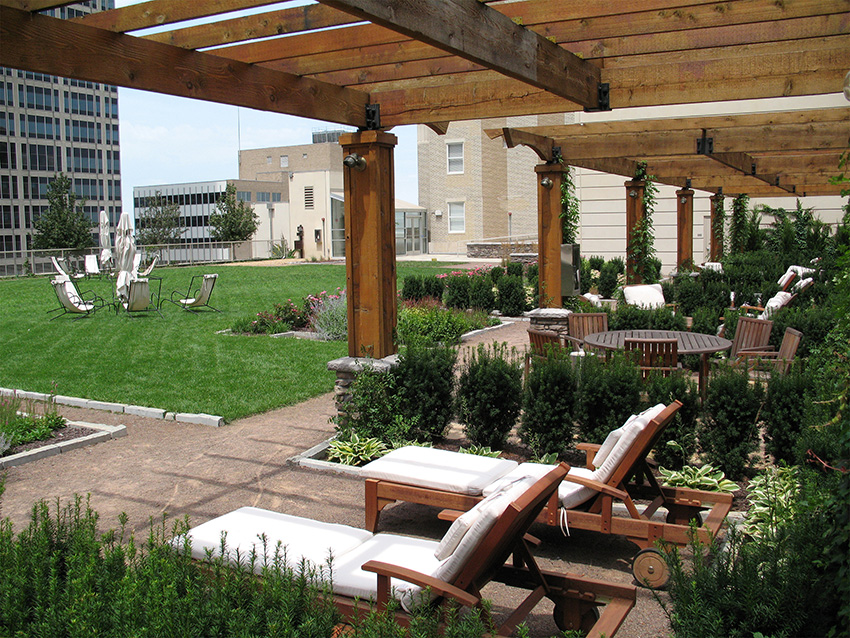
[179,464,636,636]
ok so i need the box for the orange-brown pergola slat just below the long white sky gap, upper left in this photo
[144,4,357,49]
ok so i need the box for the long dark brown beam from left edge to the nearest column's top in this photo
[0,7,369,126]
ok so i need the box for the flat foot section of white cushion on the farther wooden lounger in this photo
[361,446,517,496]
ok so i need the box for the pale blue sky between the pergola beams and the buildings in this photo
[115,0,419,211]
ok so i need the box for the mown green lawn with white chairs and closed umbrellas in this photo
[0,262,460,420]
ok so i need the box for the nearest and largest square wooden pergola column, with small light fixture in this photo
[339,131,398,359]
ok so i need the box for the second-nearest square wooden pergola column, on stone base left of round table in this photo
[534,163,564,308]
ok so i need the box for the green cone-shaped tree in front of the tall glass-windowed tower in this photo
[33,173,94,250]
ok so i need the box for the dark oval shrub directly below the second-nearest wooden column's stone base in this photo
[519,348,578,456]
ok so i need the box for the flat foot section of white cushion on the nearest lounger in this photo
[181,507,370,573]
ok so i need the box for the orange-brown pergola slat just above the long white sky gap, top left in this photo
[75,0,276,33]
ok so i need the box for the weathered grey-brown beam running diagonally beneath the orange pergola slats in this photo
[314,0,599,107]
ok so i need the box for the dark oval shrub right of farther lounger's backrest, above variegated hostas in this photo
[699,366,764,481]
